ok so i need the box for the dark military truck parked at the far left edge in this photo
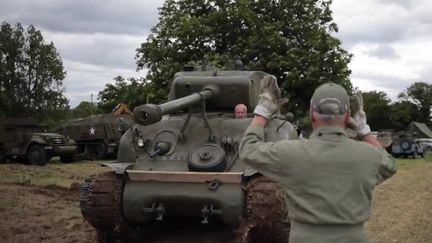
[0,117,76,165]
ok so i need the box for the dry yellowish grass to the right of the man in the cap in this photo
[366,153,432,243]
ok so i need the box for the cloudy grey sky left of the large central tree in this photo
[0,0,163,107]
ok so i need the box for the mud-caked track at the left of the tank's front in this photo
[80,172,135,243]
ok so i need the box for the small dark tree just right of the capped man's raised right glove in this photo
[363,91,391,131]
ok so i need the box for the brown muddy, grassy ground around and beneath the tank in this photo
[0,159,432,243]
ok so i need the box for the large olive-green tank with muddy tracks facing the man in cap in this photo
[80,67,298,242]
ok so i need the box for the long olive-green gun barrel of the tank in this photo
[134,88,216,125]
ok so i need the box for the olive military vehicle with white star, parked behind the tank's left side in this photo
[59,114,133,160]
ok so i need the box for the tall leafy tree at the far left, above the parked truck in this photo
[0,22,68,119]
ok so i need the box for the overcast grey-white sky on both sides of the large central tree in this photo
[0,0,432,107]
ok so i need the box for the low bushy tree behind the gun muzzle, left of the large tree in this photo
[98,76,155,113]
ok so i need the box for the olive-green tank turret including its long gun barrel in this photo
[134,70,269,125]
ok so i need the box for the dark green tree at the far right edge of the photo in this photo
[399,82,432,124]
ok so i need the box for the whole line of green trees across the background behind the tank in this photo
[0,0,432,130]
